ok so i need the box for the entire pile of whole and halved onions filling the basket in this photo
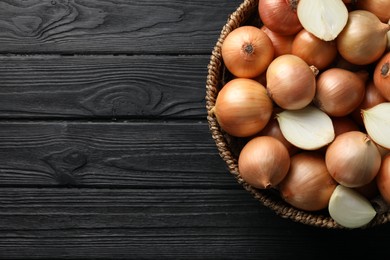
[212,0,390,228]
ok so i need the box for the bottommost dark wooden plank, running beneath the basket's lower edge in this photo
[0,188,390,259]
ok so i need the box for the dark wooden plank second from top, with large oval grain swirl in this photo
[0,55,210,119]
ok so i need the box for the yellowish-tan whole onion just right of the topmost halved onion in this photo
[336,10,390,65]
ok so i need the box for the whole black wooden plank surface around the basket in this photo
[0,0,390,259]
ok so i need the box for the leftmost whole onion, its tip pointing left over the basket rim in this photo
[212,78,273,137]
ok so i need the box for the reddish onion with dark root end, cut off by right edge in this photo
[373,52,390,101]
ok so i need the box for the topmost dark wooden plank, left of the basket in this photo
[0,0,242,54]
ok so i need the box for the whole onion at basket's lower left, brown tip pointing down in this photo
[238,136,290,189]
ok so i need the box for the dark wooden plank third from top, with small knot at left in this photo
[0,121,237,188]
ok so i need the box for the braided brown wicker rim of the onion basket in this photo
[206,0,390,229]
